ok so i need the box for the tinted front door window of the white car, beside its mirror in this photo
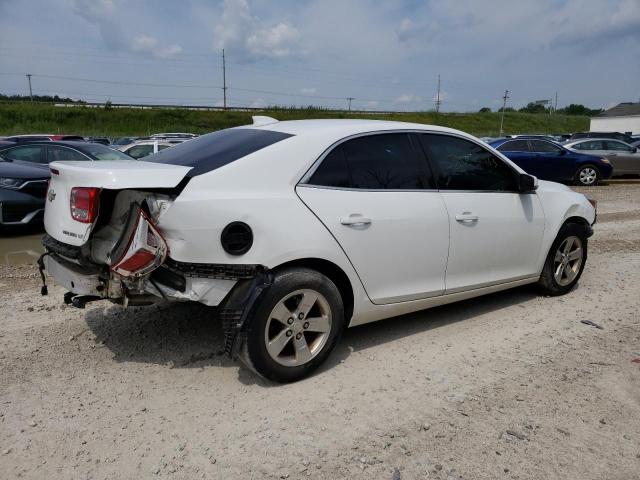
[421,134,517,191]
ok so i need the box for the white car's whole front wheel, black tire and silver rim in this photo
[538,223,587,296]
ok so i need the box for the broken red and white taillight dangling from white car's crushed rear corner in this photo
[111,209,169,277]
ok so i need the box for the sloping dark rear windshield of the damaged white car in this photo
[142,128,293,177]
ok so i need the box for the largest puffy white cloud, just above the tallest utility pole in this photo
[213,0,300,58]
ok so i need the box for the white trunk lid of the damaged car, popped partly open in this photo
[44,160,191,246]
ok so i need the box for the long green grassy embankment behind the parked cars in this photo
[0,103,589,137]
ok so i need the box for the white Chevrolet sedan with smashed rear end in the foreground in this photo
[39,117,596,382]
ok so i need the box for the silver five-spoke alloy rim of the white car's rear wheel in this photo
[264,289,332,367]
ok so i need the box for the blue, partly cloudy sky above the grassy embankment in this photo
[0,0,640,111]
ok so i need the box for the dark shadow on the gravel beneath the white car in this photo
[85,287,536,387]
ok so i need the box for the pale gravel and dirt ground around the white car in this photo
[0,182,640,480]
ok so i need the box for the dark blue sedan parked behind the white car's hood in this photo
[490,137,613,186]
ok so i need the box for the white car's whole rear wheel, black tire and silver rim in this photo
[240,268,344,383]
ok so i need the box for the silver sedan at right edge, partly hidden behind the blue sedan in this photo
[564,138,640,177]
